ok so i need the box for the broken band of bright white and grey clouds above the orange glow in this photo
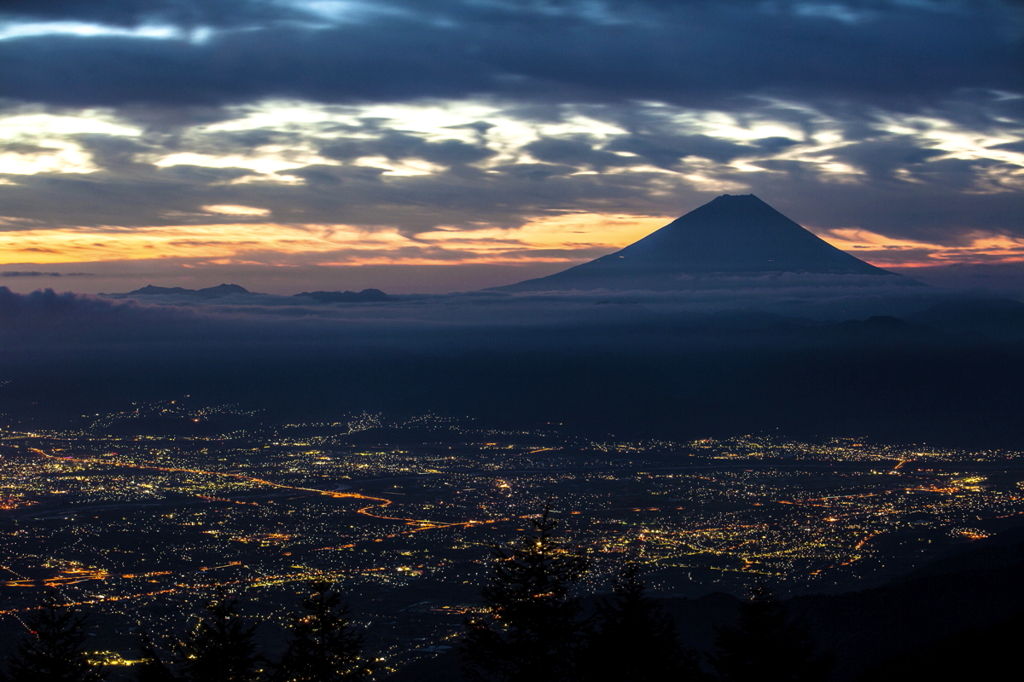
[0,93,1024,243]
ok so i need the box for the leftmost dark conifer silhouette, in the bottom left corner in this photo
[4,590,103,682]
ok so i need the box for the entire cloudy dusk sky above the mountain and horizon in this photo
[0,0,1024,294]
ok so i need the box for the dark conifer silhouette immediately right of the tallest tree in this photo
[584,562,705,682]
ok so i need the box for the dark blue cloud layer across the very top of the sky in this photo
[0,0,1024,105]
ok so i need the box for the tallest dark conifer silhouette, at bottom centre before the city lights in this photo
[461,508,589,682]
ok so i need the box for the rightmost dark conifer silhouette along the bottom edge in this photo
[712,588,830,682]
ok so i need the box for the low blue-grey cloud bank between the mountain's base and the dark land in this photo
[0,275,999,382]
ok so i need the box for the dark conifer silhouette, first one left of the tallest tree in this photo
[273,582,371,682]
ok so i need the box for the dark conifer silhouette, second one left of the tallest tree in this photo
[177,589,261,682]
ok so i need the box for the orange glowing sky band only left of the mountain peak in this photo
[0,212,671,266]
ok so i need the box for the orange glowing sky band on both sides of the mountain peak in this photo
[0,212,1024,267]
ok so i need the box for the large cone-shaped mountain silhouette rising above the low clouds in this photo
[490,195,918,293]
